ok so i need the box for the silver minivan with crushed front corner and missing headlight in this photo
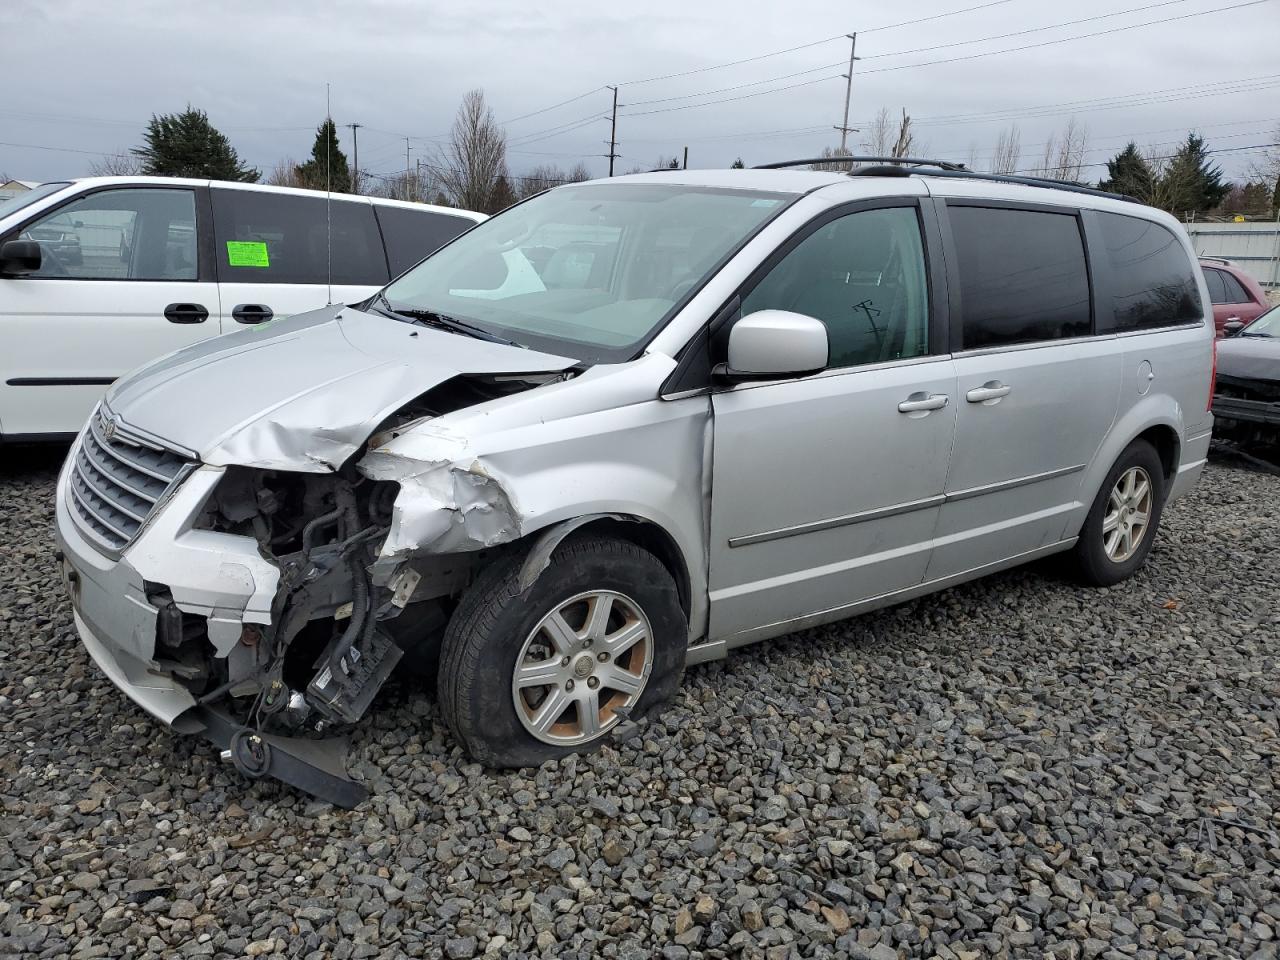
[58,161,1213,804]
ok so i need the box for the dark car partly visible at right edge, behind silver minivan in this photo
[1213,307,1280,443]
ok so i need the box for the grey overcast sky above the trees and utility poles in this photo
[0,0,1280,180]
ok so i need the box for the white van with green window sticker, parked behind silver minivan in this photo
[0,177,485,440]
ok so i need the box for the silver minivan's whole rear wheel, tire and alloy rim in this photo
[1073,440,1165,586]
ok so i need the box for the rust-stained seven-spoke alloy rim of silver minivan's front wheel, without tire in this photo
[511,590,653,745]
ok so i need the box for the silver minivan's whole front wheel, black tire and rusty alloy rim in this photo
[438,536,689,767]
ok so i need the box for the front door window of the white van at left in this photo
[18,189,196,280]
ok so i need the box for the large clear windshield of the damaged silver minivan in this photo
[380,183,794,362]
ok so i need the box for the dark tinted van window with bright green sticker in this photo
[212,188,388,285]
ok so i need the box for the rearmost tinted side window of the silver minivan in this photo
[1097,214,1198,333]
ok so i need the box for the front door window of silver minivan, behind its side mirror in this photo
[742,207,929,367]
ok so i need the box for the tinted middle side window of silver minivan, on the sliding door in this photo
[947,206,1091,349]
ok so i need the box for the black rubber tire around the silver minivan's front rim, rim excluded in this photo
[436,535,689,767]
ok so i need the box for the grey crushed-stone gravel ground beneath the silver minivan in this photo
[0,451,1280,960]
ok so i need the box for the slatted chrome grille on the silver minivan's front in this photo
[69,412,195,553]
